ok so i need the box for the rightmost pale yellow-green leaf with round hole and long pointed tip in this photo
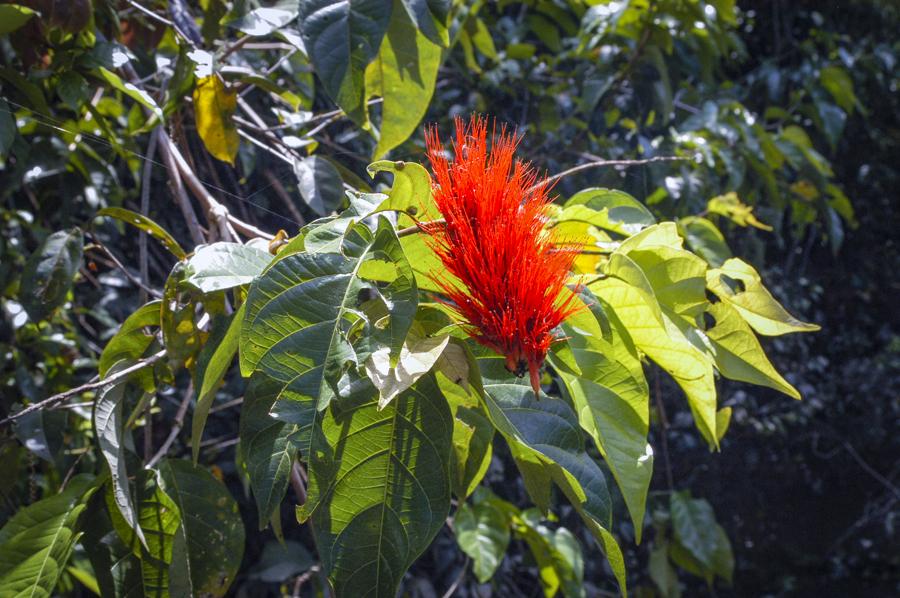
[706,258,819,336]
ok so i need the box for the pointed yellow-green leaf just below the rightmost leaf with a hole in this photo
[706,302,800,399]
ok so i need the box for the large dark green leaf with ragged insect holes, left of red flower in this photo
[241,218,417,409]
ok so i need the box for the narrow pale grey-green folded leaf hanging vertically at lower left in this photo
[94,370,147,545]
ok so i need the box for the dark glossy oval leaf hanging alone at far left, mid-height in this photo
[19,227,84,320]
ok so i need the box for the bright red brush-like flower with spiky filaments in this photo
[426,116,581,396]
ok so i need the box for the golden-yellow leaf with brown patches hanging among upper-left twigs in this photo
[194,75,240,166]
